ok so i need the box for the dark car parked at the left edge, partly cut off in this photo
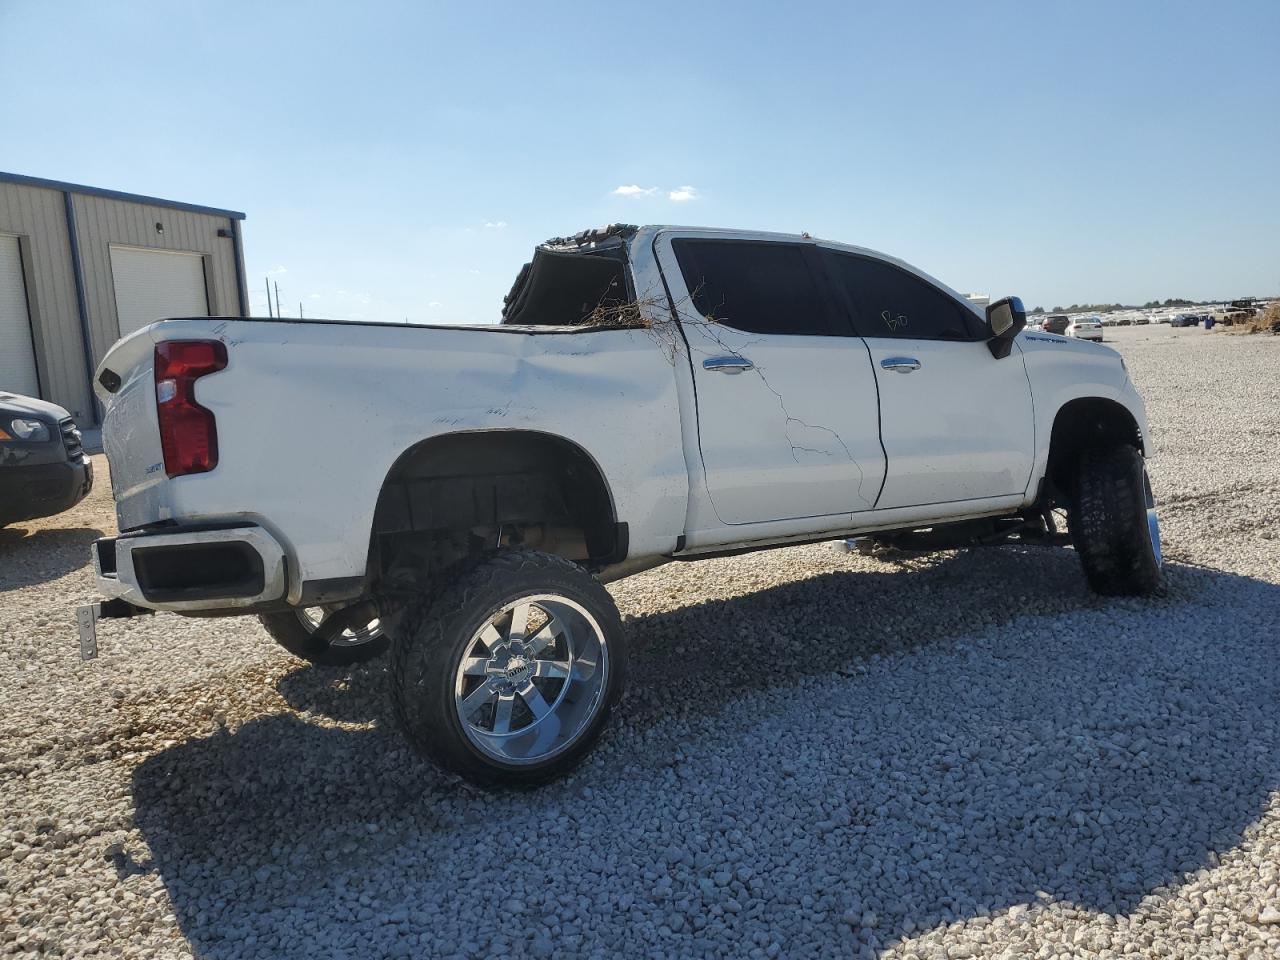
[0,392,93,526]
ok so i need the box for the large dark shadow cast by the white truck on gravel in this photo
[133,550,1280,957]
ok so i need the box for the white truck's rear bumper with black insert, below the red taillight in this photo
[92,526,287,613]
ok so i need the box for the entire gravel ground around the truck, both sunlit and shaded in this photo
[0,328,1280,959]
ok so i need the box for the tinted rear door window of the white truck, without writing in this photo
[671,241,831,335]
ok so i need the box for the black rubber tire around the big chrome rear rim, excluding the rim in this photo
[388,550,627,787]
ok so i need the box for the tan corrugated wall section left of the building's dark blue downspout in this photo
[0,183,93,422]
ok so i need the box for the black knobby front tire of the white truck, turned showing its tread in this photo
[1069,444,1161,596]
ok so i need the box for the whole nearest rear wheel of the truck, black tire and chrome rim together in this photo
[390,550,627,786]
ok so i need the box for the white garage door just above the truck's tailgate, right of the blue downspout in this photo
[111,243,209,337]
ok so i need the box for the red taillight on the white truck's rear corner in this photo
[155,340,227,476]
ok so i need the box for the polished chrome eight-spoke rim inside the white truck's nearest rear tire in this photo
[454,594,609,764]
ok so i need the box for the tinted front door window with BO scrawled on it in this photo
[829,253,980,340]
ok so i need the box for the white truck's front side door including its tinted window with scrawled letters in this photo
[826,250,1036,509]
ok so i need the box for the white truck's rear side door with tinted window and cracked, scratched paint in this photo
[657,234,884,525]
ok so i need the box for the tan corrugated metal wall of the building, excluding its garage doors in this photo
[0,180,241,426]
